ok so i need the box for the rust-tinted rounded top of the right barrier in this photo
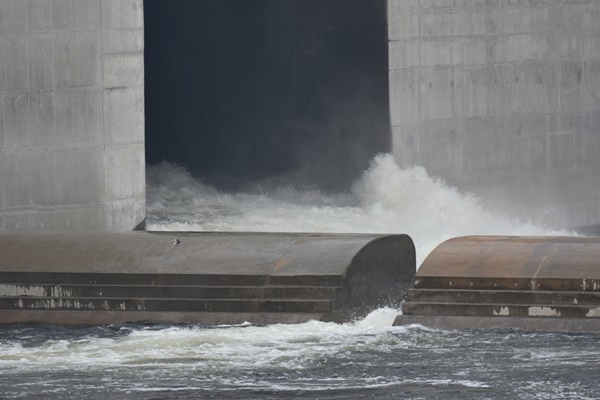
[415,236,600,290]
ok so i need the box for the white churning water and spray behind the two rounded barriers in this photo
[147,154,567,265]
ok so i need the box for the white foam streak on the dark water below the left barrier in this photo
[0,308,400,370]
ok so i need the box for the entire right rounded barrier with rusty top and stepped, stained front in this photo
[396,236,600,331]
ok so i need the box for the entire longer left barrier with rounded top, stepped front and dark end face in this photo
[0,231,415,323]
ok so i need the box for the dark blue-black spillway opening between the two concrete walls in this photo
[144,0,390,190]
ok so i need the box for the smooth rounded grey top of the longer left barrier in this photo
[0,231,410,276]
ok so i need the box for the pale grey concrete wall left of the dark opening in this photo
[0,0,145,230]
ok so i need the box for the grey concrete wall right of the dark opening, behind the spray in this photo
[388,0,600,230]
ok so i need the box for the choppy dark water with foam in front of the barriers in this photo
[0,309,600,400]
